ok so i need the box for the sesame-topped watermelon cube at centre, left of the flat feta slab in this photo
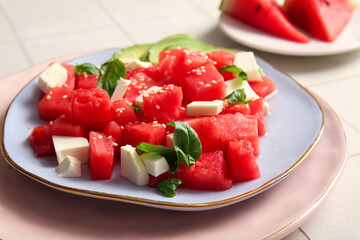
[143,85,183,123]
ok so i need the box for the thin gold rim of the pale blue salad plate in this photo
[0,49,325,210]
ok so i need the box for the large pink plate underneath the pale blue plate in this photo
[0,56,347,239]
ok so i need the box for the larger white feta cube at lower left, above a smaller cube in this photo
[52,136,89,164]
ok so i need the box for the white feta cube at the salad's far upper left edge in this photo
[38,63,67,93]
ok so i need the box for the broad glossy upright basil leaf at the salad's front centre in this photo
[167,122,202,167]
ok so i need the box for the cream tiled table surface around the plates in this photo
[0,0,360,240]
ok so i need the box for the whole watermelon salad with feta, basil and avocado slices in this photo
[28,35,276,197]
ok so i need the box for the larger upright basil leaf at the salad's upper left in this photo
[97,59,126,97]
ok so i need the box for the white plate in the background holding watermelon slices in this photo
[220,8,360,56]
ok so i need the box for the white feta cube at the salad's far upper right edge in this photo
[234,52,262,82]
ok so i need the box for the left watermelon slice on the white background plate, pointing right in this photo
[220,0,310,43]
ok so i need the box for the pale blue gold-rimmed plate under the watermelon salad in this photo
[1,49,324,210]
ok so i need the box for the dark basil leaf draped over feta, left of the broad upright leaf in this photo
[136,142,180,173]
